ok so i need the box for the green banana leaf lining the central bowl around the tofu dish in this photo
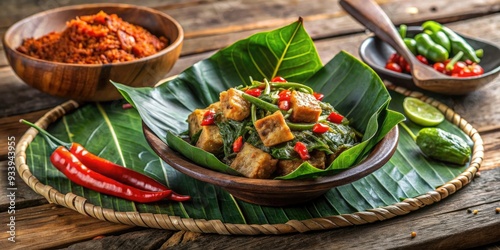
[114,20,404,179]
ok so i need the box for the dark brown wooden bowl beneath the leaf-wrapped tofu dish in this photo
[143,125,399,206]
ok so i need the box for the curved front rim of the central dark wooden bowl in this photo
[143,123,399,193]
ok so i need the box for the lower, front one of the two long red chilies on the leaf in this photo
[50,146,172,203]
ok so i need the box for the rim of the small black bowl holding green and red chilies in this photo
[358,26,500,82]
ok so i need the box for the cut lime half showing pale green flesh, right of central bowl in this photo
[403,97,444,126]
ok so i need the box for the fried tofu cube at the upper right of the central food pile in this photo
[290,91,321,123]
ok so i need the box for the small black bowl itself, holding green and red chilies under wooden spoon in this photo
[359,26,500,93]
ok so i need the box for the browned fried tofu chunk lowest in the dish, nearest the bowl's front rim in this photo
[231,142,278,179]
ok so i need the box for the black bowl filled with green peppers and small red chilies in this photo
[359,21,500,95]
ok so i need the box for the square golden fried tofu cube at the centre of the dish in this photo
[254,110,295,147]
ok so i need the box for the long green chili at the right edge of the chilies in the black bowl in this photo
[422,21,481,63]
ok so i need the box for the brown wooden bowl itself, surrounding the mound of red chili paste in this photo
[3,4,184,101]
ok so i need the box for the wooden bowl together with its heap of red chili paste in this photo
[3,3,184,101]
